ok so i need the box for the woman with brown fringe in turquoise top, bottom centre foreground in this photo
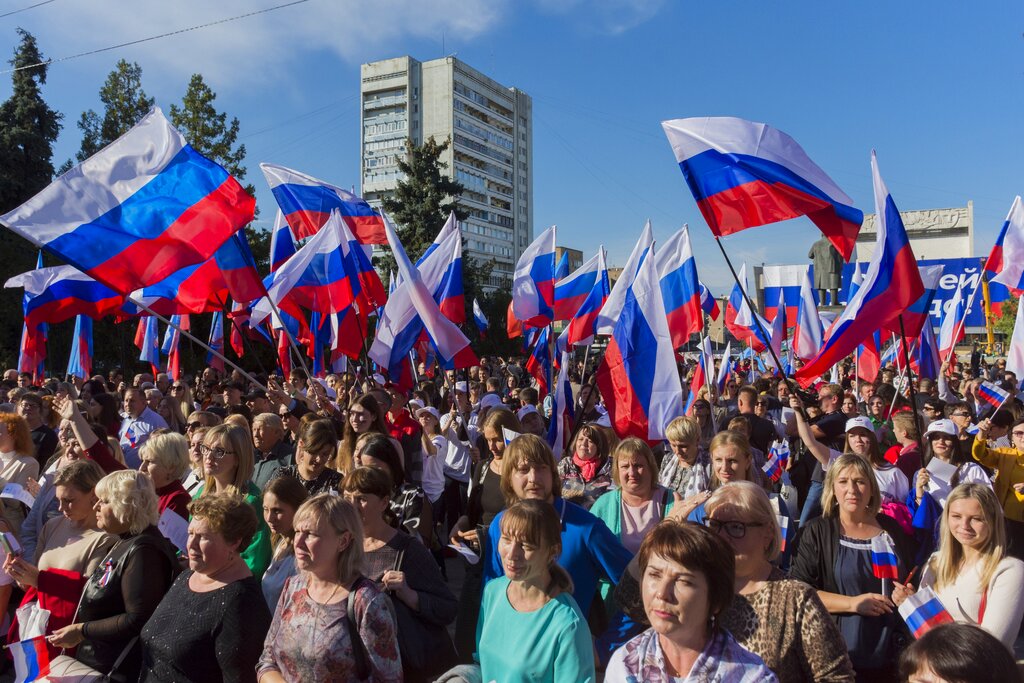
[476,500,597,683]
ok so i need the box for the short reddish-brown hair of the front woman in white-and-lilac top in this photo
[638,519,736,618]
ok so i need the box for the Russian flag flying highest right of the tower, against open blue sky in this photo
[662,117,864,260]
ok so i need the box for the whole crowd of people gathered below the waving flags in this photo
[0,344,1024,683]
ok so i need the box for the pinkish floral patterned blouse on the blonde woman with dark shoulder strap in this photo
[257,572,401,683]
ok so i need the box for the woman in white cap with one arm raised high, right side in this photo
[790,394,910,506]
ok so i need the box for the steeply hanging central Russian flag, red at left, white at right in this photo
[597,241,683,442]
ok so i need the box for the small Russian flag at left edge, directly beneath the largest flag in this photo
[4,265,125,326]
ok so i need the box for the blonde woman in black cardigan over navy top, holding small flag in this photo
[790,454,913,681]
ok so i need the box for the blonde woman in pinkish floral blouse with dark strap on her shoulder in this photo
[256,494,401,683]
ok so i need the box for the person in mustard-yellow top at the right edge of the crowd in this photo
[971,418,1024,559]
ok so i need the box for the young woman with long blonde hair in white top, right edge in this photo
[893,483,1024,651]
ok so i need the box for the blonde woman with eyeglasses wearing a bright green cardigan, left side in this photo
[195,425,272,577]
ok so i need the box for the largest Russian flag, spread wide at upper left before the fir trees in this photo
[0,108,256,293]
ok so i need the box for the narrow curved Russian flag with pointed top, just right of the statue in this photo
[796,156,925,387]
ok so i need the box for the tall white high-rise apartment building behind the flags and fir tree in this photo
[359,56,534,288]
